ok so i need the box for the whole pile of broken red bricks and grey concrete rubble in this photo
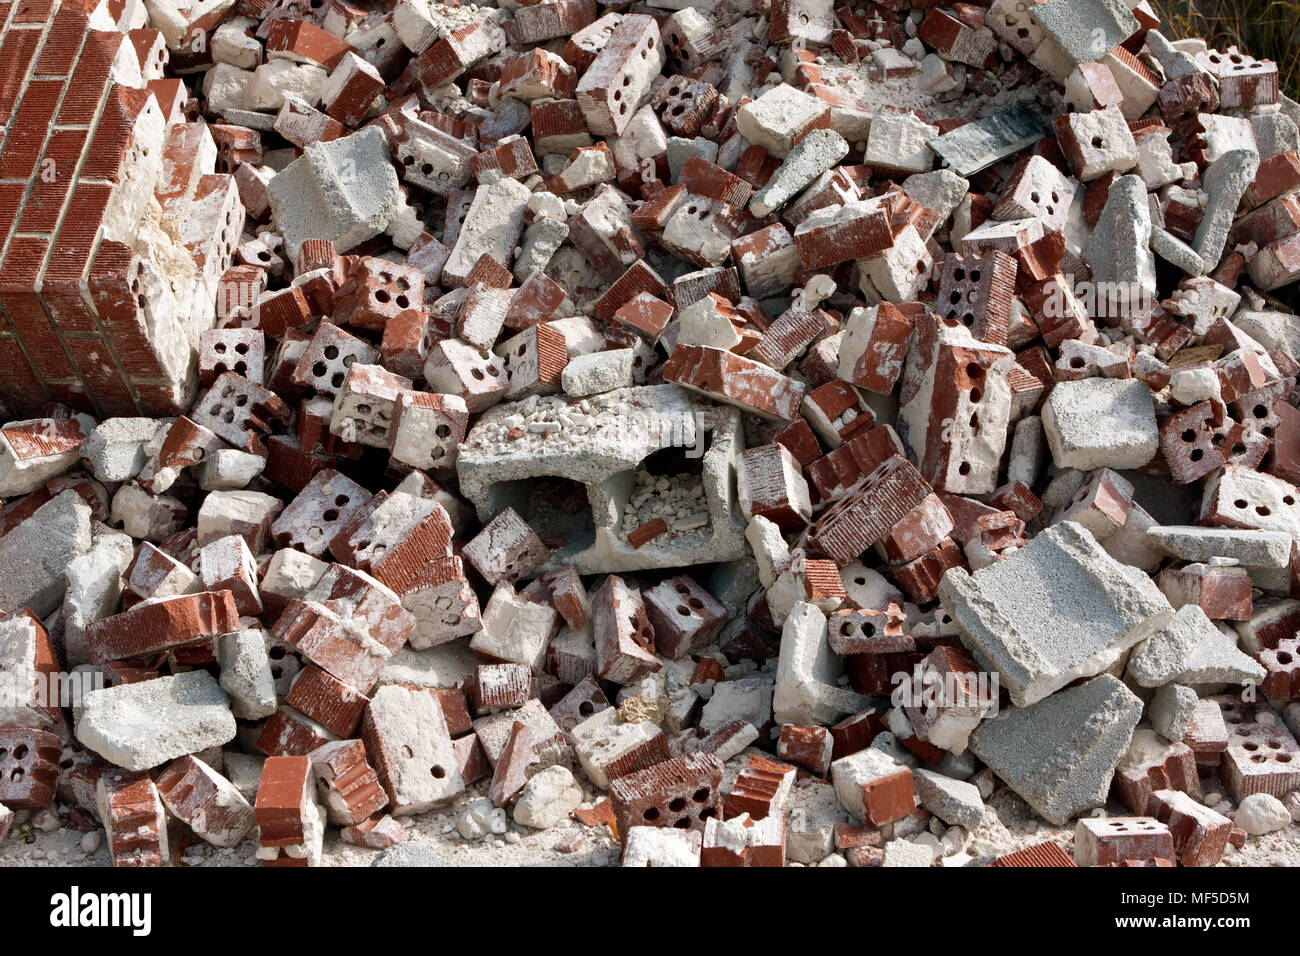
[0,0,1300,866]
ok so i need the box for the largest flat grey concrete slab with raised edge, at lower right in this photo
[939,522,1173,708]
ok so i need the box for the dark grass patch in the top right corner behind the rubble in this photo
[1154,0,1300,99]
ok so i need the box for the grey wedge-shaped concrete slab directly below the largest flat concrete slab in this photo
[971,674,1141,826]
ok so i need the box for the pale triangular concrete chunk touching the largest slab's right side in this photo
[1128,604,1265,687]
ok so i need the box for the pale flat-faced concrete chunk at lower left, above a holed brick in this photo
[77,671,235,770]
